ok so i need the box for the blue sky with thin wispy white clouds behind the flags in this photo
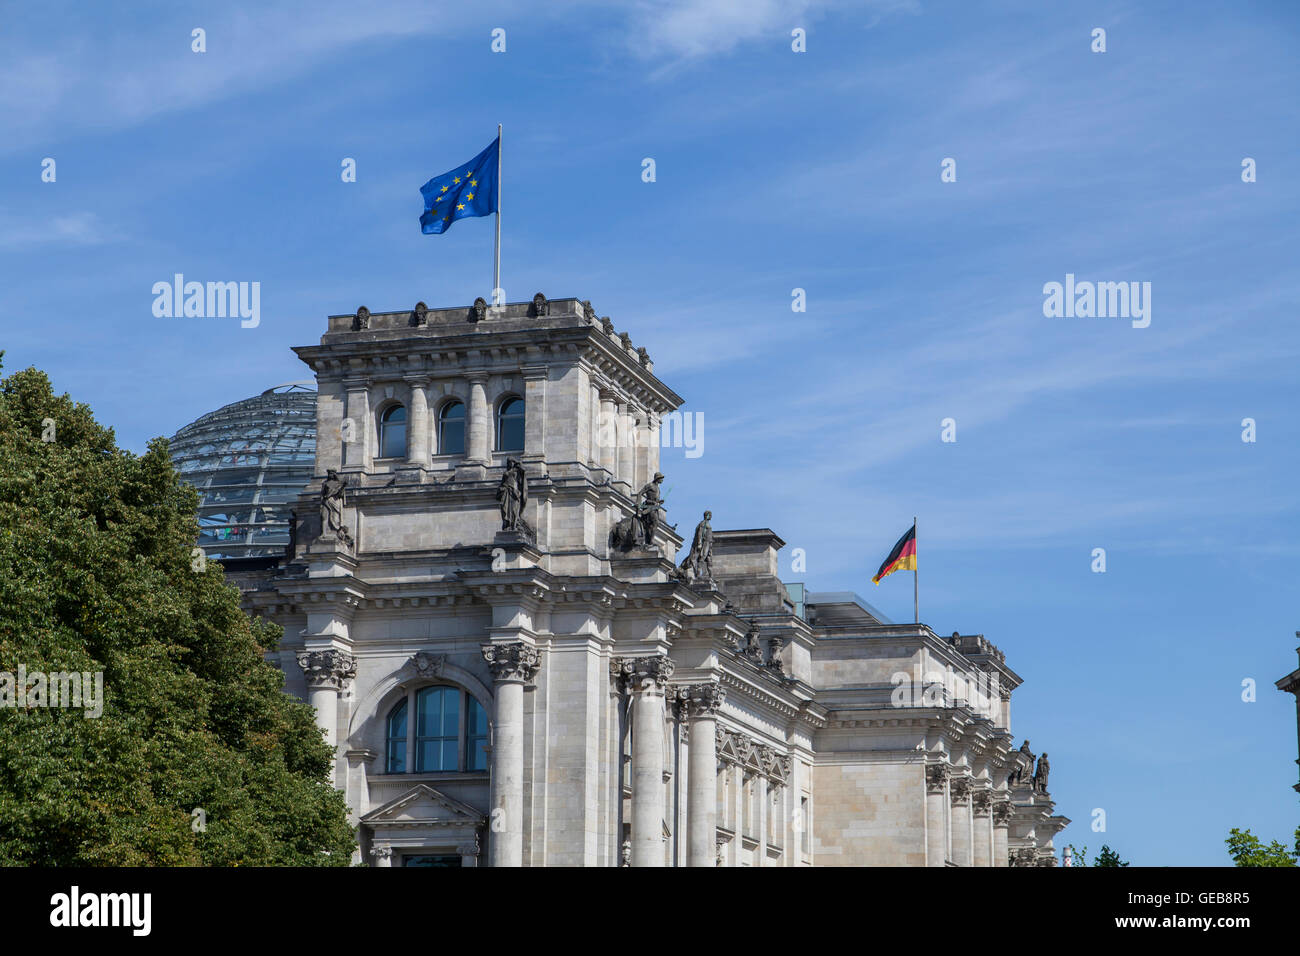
[0,0,1300,865]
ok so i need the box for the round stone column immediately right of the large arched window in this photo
[482,641,540,866]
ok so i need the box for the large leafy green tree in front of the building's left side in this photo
[0,354,355,866]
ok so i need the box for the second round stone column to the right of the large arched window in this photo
[614,654,673,866]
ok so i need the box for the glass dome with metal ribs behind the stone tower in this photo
[170,381,316,558]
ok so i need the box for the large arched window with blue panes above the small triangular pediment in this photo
[386,685,488,774]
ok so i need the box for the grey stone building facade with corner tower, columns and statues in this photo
[228,294,1069,866]
